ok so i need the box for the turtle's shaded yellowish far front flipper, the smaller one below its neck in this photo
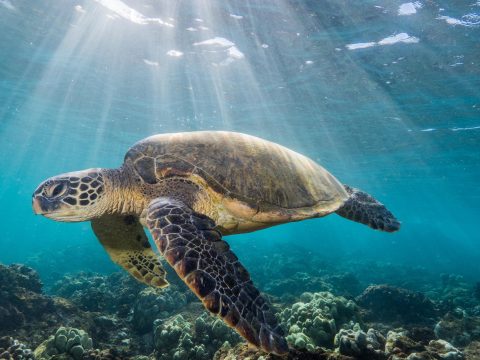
[92,215,168,288]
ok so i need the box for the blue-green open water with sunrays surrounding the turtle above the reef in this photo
[0,0,480,280]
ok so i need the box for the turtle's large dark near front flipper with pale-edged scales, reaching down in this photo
[146,198,288,354]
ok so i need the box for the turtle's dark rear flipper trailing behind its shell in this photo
[336,185,400,232]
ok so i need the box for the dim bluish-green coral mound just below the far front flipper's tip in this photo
[133,285,187,334]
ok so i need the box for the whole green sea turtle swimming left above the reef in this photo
[33,131,400,354]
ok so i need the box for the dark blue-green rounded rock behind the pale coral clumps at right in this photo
[356,285,436,325]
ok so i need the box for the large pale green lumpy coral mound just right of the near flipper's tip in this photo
[280,292,357,351]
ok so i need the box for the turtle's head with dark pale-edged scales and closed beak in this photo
[32,169,105,222]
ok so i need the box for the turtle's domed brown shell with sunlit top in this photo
[125,131,348,209]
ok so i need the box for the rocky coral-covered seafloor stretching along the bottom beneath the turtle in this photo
[0,251,480,360]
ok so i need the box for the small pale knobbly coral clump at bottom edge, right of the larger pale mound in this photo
[334,324,386,360]
